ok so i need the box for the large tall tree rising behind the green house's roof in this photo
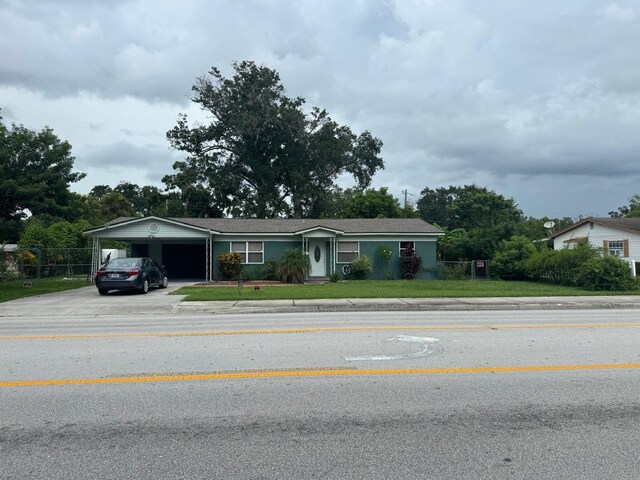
[163,61,384,218]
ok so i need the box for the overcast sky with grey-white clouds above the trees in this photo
[0,0,640,218]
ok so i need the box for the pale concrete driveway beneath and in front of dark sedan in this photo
[0,282,191,317]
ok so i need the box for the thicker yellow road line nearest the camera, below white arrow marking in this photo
[0,363,640,388]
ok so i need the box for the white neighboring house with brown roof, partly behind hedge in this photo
[551,217,640,276]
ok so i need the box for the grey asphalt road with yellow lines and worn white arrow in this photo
[0,310,640,479]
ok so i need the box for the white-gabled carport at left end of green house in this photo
[85,217,218,281]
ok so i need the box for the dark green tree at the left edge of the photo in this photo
[0,117,84,241]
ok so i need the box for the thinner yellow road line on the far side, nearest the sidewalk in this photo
[0,323,640,341]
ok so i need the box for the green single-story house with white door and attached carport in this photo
[85,216,444,281]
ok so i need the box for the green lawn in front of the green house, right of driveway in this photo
[174,280,638,301]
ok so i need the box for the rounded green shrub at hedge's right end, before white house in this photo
[576,257,636,291]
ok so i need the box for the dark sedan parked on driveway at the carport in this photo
[96,257,169,295]
